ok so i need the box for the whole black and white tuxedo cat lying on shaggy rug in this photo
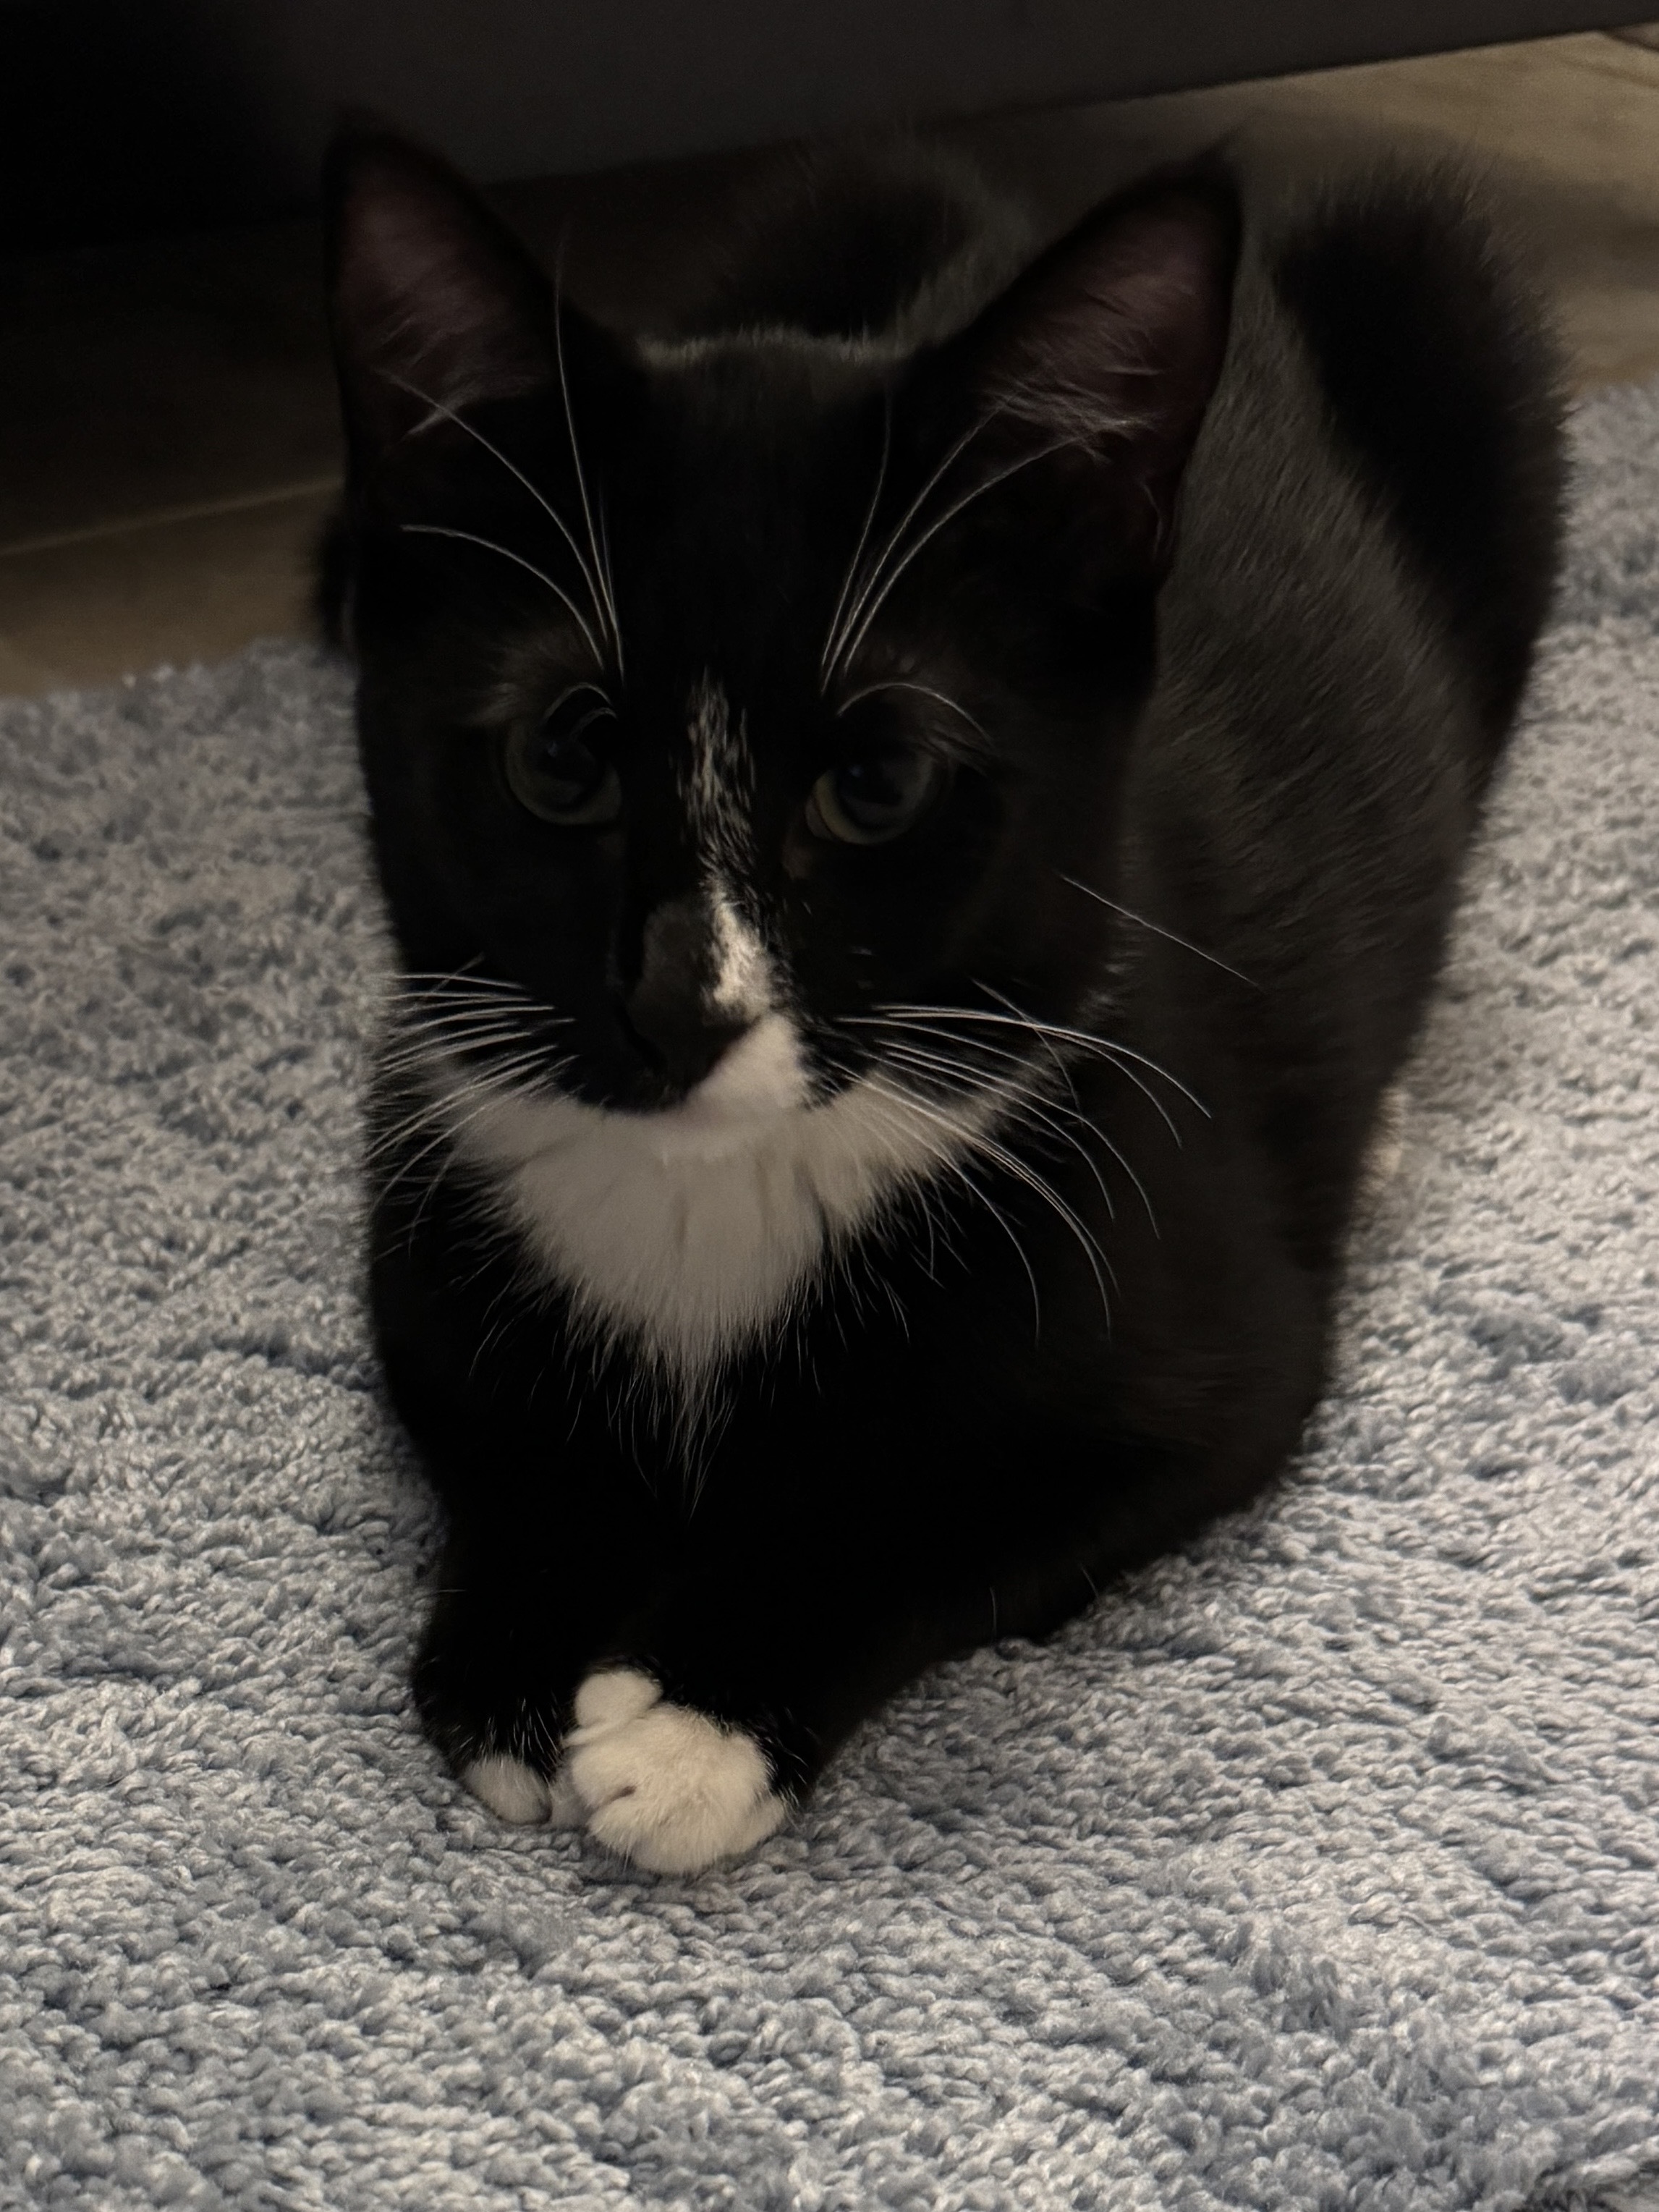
[330,132,1559,1871]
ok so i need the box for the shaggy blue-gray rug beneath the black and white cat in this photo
[0,391,1659,2212]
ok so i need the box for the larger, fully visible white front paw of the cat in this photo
[555,1668,789,1873]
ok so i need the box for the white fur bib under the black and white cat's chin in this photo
[433,1013,1006,1385]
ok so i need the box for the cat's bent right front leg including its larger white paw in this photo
[546,1418,1276,1873]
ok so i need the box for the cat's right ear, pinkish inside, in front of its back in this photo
[911,161,1241,571]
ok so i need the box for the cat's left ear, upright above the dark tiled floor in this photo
[325,128,557,462]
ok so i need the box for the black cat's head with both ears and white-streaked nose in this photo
[332,135,1239,1141]
